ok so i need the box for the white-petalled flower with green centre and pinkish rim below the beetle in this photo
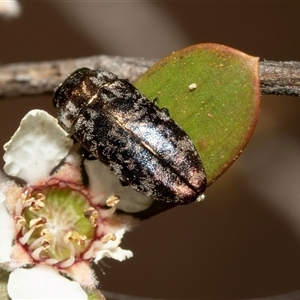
[0,110,136,300]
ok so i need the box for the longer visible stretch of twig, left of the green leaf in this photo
[0,55,156,98]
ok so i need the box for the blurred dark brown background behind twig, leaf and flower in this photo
[0,1,300,299]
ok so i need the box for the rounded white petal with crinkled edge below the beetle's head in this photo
[3,110,73,183]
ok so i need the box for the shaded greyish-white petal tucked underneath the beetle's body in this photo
[84,160,153,212]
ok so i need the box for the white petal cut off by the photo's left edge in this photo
[0,192,15,263]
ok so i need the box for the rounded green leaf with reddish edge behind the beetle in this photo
[135,44,260,185]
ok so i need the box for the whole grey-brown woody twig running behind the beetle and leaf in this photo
[0,55,300,98]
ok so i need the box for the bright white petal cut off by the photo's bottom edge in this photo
[7,265,88,300]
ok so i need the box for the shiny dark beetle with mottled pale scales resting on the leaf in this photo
[53,68,206,204]
